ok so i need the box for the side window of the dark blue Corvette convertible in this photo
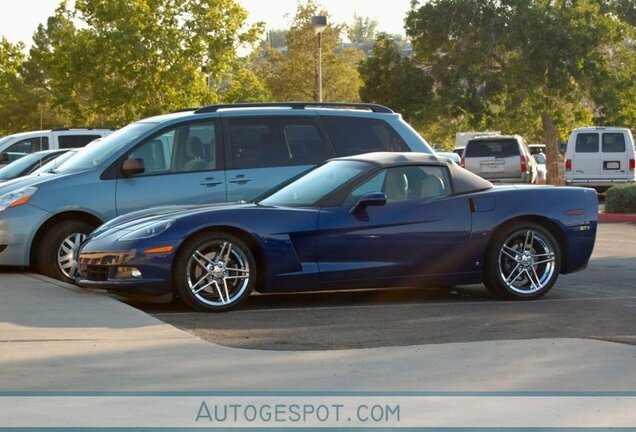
[345,165,451,205]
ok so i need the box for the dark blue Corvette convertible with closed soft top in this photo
[77,153,598,311]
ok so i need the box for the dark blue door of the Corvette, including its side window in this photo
[316,166,471,282]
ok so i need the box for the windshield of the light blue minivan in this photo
[57,123,156,173]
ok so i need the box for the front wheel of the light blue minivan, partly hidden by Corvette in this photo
[36,220,95,283]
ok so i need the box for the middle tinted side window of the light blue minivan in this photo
[228,117,327,168]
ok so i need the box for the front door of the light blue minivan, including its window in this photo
[116,119,227,214]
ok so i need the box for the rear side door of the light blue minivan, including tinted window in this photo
[225,115,328,201]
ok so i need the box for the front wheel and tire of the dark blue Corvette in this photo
[173,232,258,312]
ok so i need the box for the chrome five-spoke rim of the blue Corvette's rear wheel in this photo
[499,229,556,294]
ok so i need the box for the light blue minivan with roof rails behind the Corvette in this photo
[0,103,432,280]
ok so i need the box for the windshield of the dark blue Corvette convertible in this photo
[258,161,373,207]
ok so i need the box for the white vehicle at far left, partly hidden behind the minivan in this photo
[0,128,113,166]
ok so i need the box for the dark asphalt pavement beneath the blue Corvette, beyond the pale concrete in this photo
[124,224,636,350]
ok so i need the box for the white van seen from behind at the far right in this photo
[565,127,636,190]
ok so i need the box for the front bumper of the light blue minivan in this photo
[0,204,51,266]
